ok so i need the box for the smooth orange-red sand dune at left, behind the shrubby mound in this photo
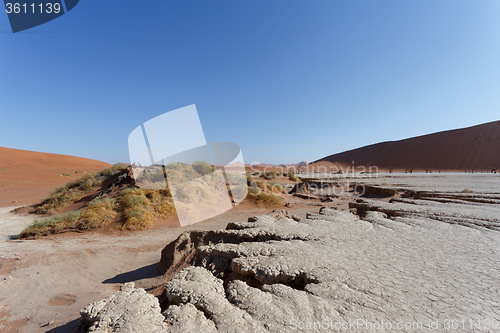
[0,147,111,207]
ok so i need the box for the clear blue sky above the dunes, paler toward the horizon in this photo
[0,0,500,163]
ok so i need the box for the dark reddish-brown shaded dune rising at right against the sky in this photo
[311,121,500,172]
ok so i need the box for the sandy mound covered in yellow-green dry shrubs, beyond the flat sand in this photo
[14,164,291,239]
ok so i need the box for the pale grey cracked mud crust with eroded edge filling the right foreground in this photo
[78,184,500,332]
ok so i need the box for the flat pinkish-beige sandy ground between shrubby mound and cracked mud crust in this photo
[0,202,324,333]
